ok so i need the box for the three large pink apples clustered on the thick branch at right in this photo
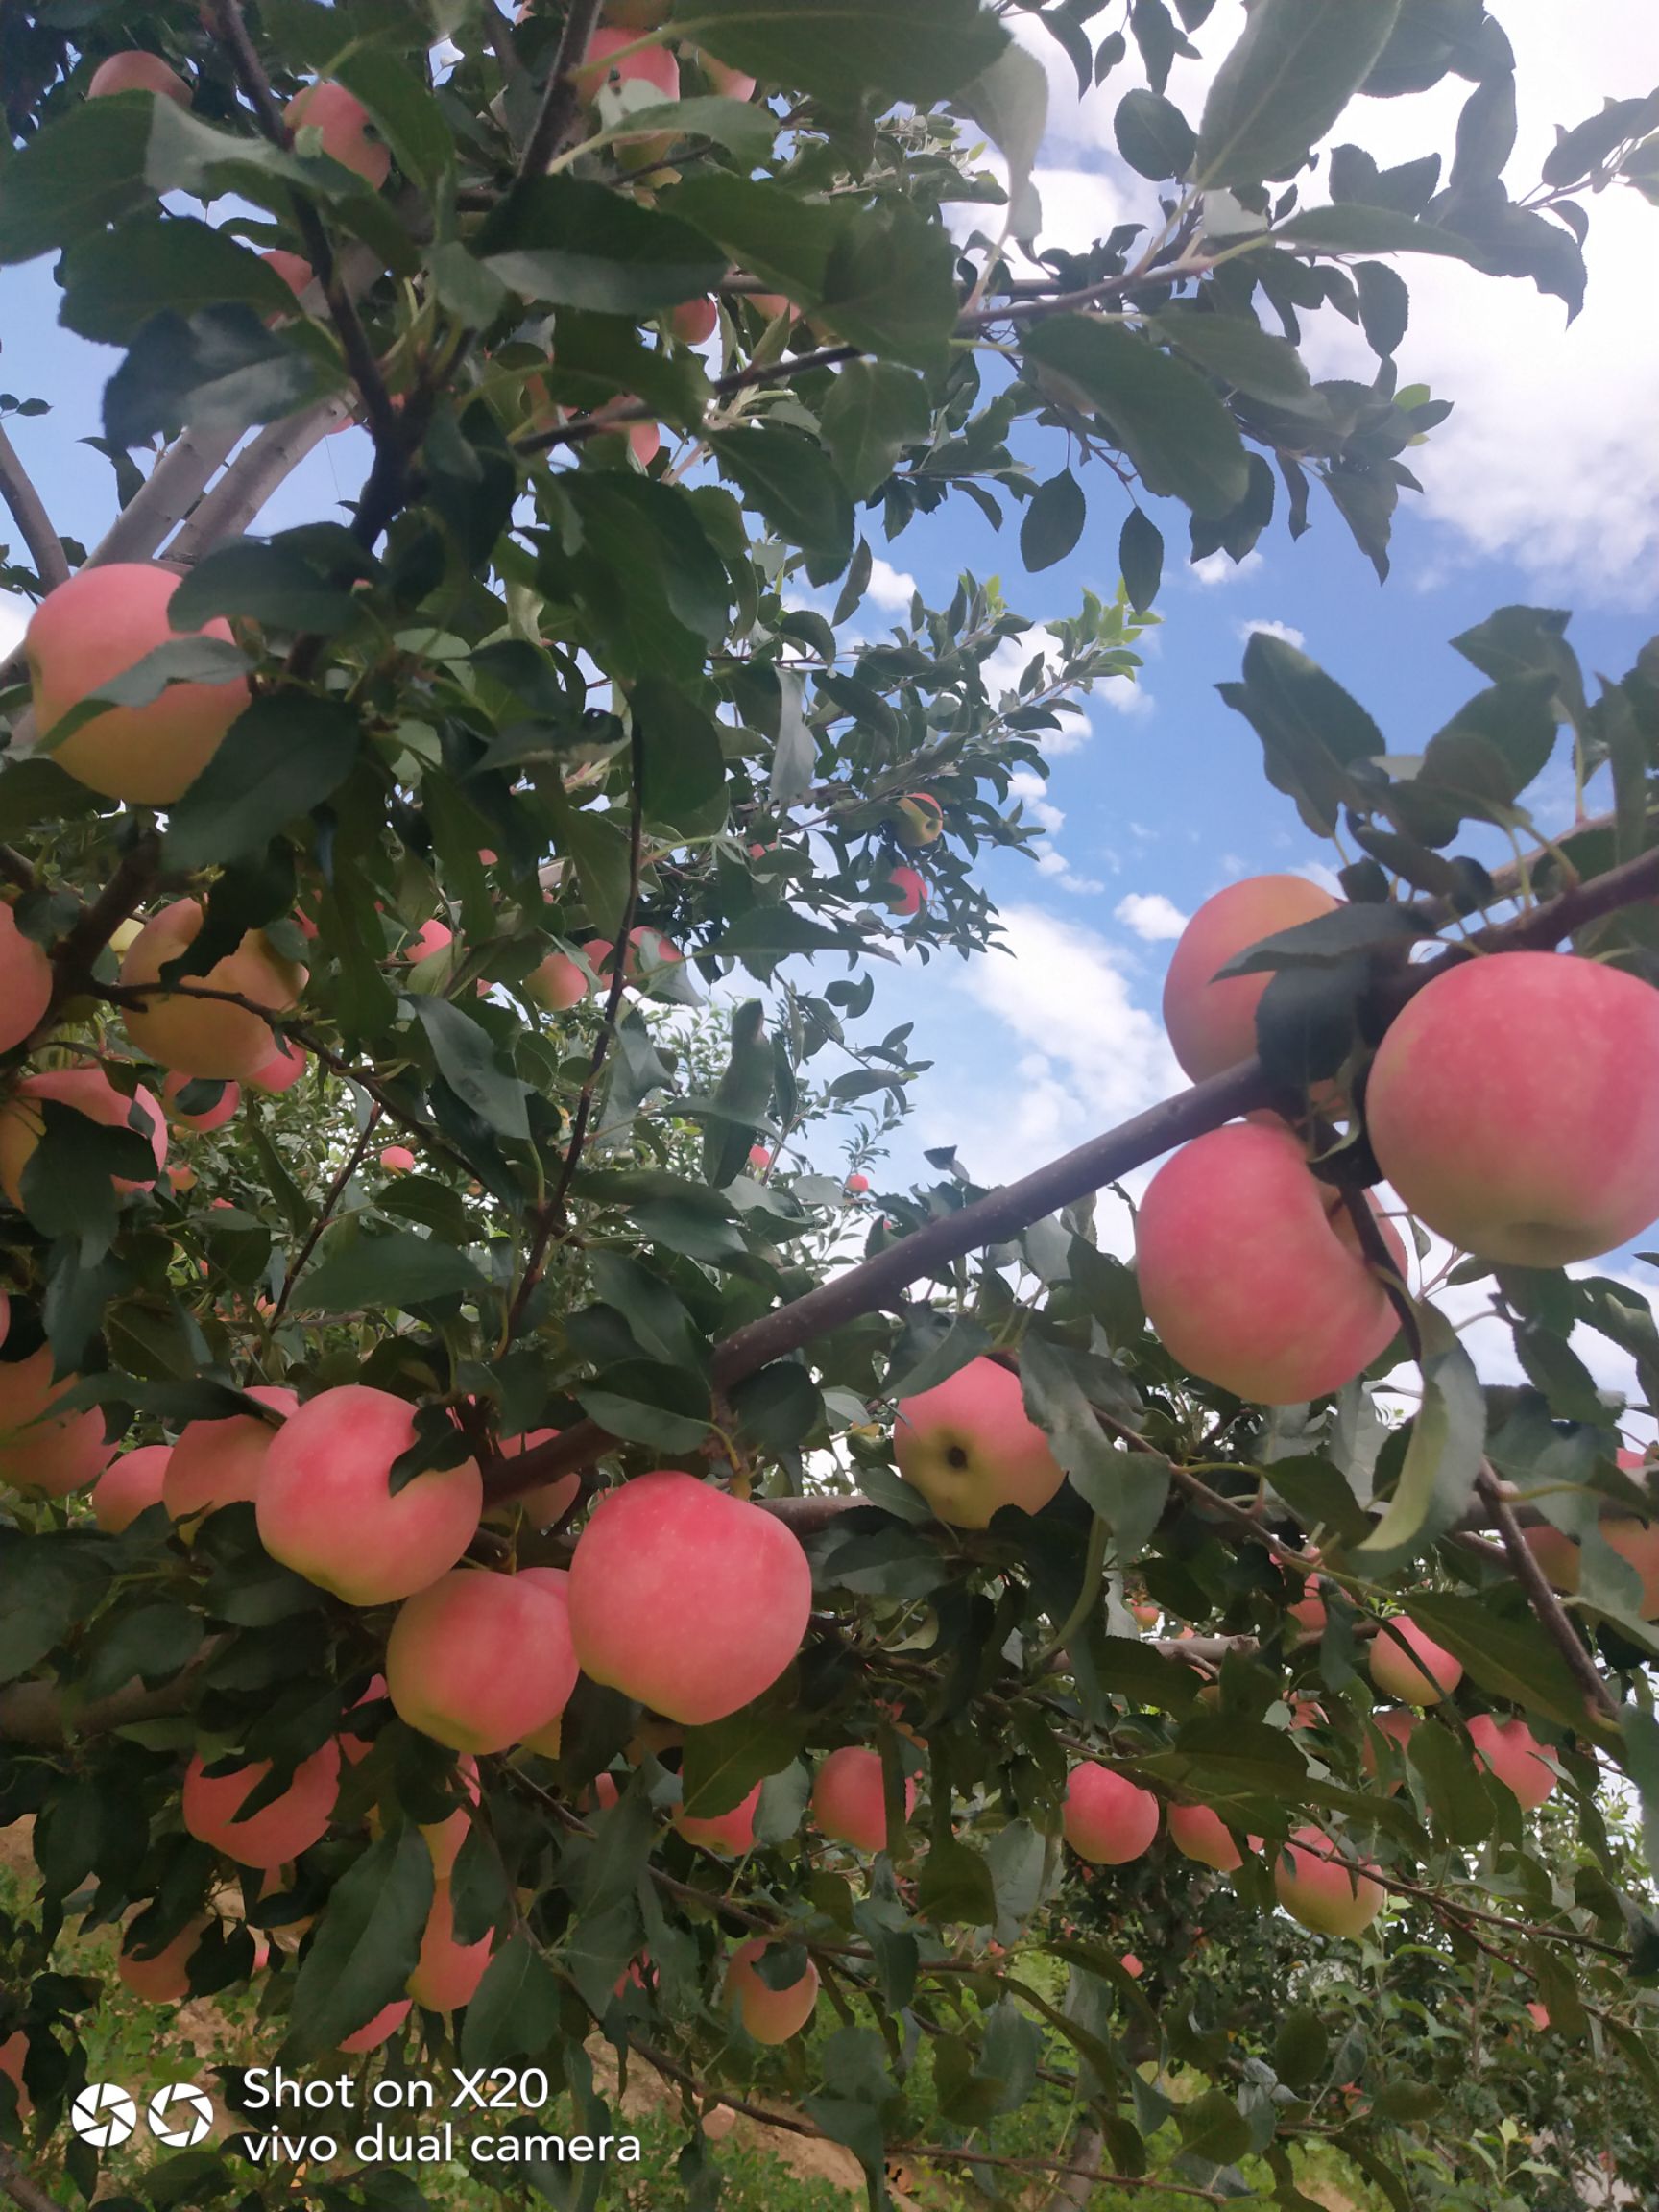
[1135,876,1659,1405]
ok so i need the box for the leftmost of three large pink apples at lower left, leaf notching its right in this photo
[254,1382,485,1606]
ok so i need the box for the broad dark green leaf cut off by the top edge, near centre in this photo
[675,0,1009,107]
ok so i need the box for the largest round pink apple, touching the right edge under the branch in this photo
[1365,953,1659,1267]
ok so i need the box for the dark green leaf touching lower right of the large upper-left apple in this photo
[163,690,363,869]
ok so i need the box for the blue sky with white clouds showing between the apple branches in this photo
[0,0,1659,1388]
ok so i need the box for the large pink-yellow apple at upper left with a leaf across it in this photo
[24,562,248,807]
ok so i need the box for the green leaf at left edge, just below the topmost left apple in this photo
[0,93,152,268]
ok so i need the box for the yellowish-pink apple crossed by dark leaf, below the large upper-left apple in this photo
[122,898,307,1082]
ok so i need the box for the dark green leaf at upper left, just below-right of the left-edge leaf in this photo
[60,217,294,345]
